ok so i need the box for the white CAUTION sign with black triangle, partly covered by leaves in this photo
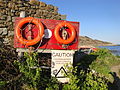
[51,50,74,83]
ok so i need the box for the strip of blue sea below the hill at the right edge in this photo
[99,46,120,56]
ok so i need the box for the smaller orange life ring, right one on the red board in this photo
[54,22,76,44]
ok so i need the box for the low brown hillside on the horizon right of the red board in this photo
[79,36,114,46]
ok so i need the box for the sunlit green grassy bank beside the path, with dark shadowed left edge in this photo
[80,49,120,79]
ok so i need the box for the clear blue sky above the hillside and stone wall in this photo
[40,0,120,44]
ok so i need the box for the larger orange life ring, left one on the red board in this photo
[15,17,44,46]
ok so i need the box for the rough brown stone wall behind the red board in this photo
[0,0,66,44]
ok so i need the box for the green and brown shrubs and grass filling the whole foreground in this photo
[0,43,120,90]
